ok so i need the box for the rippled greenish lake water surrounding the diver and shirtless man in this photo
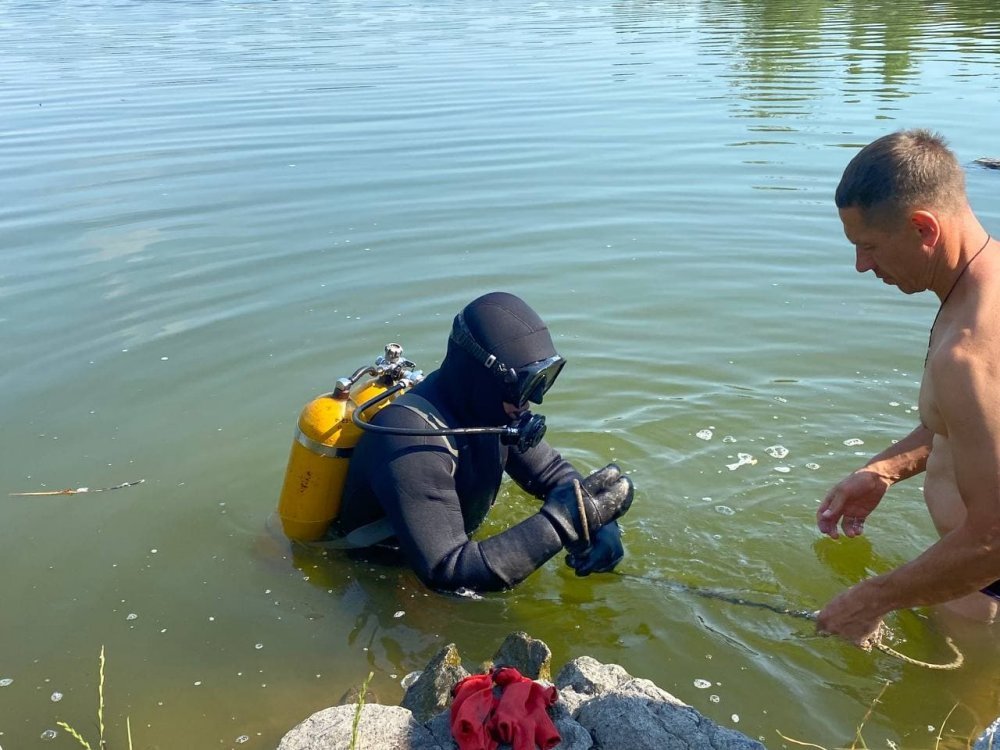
[0,0,1000,750]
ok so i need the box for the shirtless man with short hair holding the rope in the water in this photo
[816,130,1000,647]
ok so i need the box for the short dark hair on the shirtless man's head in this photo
[834,129,967,221]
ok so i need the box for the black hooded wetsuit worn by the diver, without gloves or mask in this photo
[337,293,631,591]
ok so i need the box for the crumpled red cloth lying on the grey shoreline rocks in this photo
[451,667,562,750]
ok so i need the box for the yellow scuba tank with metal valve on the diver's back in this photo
[278,344,420,542]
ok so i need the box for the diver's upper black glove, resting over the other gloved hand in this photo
[541,464,635,555]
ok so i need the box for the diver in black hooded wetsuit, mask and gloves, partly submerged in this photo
[335,292,633,591]
